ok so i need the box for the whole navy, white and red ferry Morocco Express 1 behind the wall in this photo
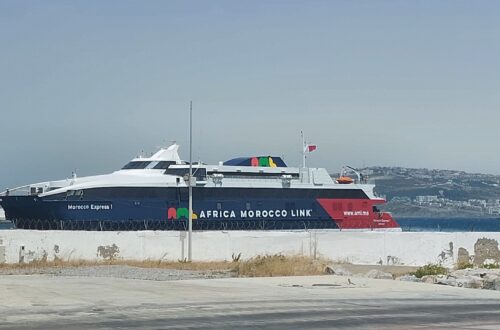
[0,144,400,230]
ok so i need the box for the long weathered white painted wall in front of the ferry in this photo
[0,230,500,266]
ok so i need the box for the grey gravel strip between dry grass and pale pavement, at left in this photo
[0,265,233,281]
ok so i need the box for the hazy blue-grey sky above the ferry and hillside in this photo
[0,0,500,188]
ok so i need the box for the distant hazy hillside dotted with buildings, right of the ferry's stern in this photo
[336,167,500,217]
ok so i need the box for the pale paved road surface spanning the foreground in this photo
[0,275,500,329]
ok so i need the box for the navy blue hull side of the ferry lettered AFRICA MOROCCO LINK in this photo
[0,188,374,230]
